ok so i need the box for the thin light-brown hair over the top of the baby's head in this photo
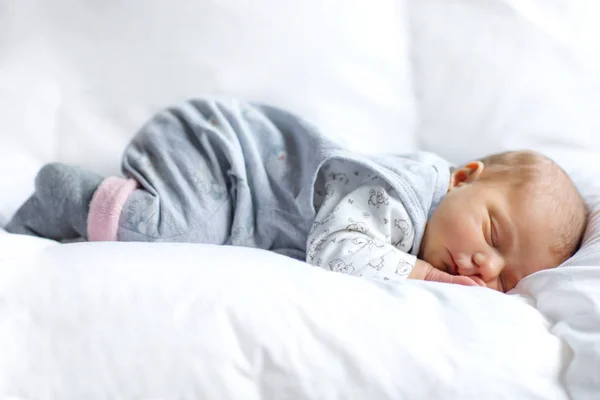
[479,151,588,263]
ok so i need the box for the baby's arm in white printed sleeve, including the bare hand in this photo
[307,179,475,285]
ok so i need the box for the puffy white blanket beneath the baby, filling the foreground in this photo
[0,235,576,400]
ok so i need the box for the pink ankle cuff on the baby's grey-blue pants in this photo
[88,177,138,242]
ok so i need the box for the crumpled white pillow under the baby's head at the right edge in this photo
[513,147,600,399]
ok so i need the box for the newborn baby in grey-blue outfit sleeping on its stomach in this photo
[6,99,587,292]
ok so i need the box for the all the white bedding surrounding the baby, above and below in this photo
[0,0,600,400]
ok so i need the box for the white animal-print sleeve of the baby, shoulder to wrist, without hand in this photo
[306,160,417,281]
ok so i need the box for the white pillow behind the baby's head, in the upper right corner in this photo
[409,0,600,162]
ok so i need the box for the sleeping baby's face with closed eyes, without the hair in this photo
[419,164,559,292]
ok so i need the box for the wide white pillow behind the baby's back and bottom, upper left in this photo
[0,0,415,175]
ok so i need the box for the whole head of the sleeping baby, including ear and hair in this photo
[419,151,587,292]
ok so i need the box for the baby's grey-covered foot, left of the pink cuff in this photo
[6,163,103,240]
